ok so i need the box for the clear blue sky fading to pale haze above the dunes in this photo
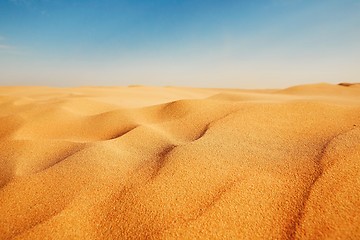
[0,0,360,88]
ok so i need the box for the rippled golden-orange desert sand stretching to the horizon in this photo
[0,83,360,239]
